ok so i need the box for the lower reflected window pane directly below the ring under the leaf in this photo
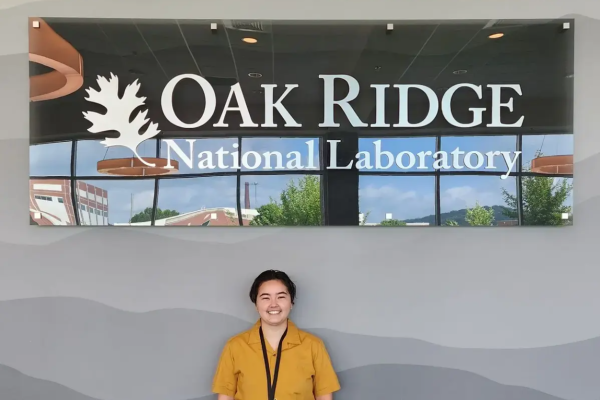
[76,179,154,226]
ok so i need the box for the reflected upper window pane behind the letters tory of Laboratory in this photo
[440,136,520,172]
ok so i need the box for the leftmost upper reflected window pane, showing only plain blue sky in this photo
[29,142,72,176]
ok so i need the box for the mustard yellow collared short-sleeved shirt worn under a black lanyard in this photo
[212,320,340,400]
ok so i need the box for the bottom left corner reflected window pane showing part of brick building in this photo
[29,179,76,225]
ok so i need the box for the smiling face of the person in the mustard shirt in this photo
[256,280,292,325]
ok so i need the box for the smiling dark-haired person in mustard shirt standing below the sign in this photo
[212,270,340,400]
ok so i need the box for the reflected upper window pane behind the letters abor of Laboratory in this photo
[357,137,436,172]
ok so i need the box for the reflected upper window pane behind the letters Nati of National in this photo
[160,138,238,174]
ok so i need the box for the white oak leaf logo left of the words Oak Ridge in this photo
[83,72,160,167]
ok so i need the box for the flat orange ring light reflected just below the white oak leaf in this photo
[96,157,179,176]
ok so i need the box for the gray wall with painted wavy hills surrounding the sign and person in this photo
[0,0,600,400]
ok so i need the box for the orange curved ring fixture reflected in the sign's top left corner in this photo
[29,18,83,101]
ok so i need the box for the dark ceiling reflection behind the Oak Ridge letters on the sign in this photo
[30,18,573,142]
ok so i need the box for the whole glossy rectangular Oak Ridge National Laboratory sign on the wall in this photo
[28,17,574,227]
